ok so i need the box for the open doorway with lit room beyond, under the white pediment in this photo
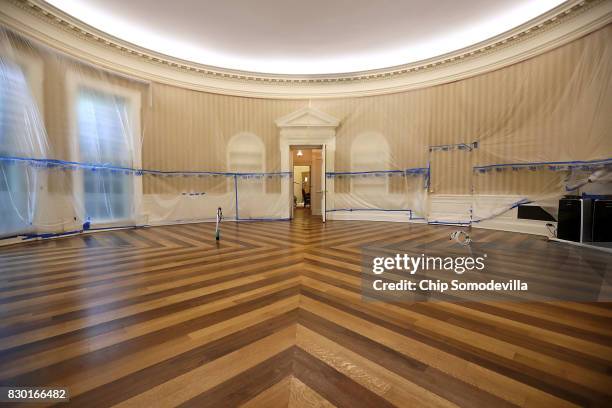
[289,145,325,218]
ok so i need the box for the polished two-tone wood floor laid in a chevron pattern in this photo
[0,209,612,407]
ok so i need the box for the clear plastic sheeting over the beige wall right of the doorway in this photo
[313,22,612,225]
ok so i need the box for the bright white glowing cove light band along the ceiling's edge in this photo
[47,0,564,74]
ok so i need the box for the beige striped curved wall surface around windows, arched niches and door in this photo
[2,11,612,234]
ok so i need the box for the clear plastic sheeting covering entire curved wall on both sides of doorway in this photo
[0,22,612,242]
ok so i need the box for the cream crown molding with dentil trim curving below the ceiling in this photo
[0,0,612,99]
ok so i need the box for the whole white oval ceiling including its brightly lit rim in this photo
[47,0,564,74]
